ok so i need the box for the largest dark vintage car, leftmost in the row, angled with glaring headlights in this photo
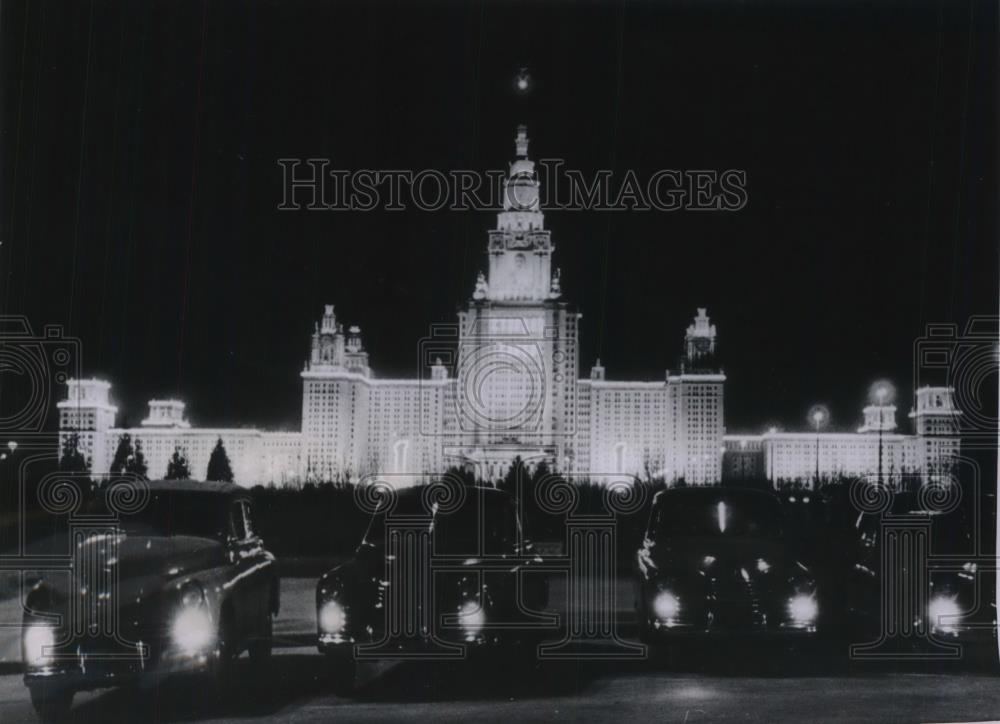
[22,480,280,720]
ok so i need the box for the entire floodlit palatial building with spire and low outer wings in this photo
[59,126,958,485]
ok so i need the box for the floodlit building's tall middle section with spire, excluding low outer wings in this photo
[302,126,725,484]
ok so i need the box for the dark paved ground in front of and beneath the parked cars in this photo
[0,579,1000,724]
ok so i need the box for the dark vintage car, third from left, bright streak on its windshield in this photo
[636,487,819,644]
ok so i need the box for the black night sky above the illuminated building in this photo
[0,0,1000,430]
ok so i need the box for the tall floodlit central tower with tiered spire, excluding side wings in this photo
[451,125,580,478]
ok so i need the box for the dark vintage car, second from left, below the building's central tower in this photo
[316,484,551,693]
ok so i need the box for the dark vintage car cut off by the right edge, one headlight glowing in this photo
[846,486,997,660]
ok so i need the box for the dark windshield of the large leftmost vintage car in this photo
[98,490,225,538]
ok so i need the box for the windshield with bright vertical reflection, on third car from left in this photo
[650,495,783,539]
